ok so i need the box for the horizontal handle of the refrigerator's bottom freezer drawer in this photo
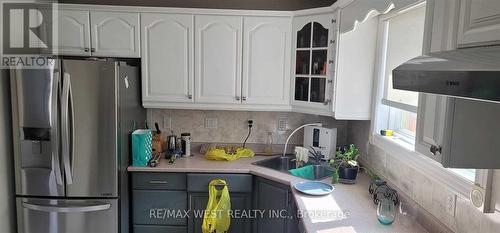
[23,202,111,213]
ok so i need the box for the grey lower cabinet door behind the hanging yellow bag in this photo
[188,193,252,233]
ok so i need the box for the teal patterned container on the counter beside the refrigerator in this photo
[132,129,153,167]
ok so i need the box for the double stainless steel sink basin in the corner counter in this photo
[253,156,333,180]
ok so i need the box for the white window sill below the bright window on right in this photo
[370,134,474,199]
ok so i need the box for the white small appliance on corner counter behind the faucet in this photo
[304,126,337,160]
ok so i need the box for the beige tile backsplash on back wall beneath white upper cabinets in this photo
[148,109,348,145]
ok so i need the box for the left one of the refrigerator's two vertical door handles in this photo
[51,71,63,185]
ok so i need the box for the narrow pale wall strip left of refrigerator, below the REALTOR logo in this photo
[0,70,15,233]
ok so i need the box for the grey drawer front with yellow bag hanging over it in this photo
[187,173,252,193]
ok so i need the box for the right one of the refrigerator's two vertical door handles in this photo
[61,73,74,184]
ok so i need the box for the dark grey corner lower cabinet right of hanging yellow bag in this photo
[253,177,299,233]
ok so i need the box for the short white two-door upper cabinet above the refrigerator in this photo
[52,4,141,57]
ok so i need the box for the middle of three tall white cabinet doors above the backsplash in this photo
[195,15,243,103]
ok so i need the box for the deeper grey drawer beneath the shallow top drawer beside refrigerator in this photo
[132,190,188,226]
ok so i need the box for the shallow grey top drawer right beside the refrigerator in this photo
[132,172,186,190]
